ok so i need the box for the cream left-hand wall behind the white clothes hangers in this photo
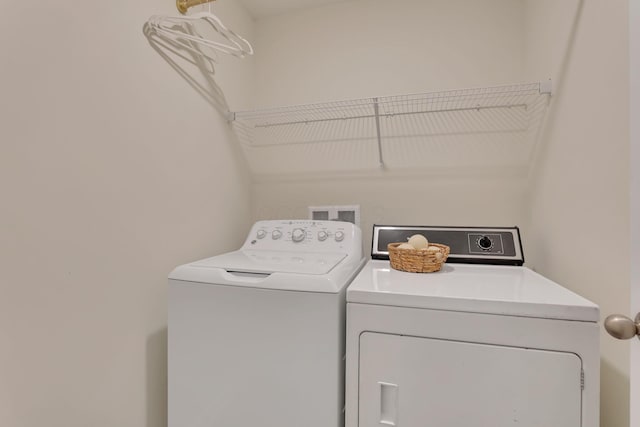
[0,0,251,427]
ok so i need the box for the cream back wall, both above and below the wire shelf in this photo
[253,0,528,252]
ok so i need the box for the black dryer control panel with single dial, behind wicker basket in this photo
[371,225,524,265]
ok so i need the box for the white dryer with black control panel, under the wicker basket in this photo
[346,226,600,427]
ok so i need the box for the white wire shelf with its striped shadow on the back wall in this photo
[232,81,551,174]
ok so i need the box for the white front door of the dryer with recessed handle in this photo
[358,332,582,427]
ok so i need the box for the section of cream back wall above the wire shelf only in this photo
[250,0,524,107]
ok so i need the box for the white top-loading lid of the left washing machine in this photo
[191,249,347,275]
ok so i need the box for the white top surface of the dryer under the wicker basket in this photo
[347,261,600,322]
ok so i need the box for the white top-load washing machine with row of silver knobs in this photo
[168,220,364,427]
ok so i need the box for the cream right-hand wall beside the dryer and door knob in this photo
[527,0,630,427]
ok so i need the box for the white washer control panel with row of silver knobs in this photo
[243,220,361,252]
